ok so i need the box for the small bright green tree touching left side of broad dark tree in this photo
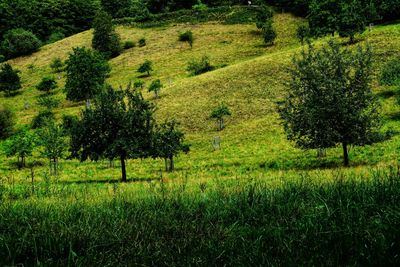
[38,121,68,175]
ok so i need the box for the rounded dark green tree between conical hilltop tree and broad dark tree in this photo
[65,48,111,106]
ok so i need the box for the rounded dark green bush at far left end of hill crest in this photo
[1,29,41,58]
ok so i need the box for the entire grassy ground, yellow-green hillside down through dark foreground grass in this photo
[0,11,400,266]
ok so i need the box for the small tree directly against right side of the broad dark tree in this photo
[153,120,189,171]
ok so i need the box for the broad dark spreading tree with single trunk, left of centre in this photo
[70,87,155,182]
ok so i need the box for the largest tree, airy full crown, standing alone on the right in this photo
[279,41,379,166]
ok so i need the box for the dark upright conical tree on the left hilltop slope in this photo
[92,10,122,58]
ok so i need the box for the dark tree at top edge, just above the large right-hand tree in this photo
[337,0,367,43]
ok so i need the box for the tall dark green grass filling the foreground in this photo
[0,169,400,266]
